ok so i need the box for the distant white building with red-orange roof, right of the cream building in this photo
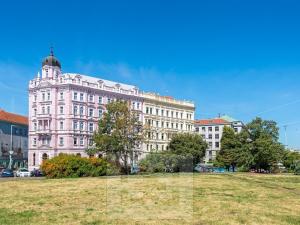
[195,116,243,163]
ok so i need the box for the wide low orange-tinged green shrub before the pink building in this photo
[41,154,118,178]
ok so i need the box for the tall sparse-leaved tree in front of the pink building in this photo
[88,101,143,174]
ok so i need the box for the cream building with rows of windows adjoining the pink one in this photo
[142,93,195,155]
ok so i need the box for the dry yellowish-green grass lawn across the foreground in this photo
[0,173,300,225]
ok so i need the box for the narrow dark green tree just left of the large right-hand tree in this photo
[216,127,242,171]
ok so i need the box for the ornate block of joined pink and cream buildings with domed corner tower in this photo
[28,51,195,170]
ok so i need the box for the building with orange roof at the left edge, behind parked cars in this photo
[0,110,28,168]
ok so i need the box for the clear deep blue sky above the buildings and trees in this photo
[0,0,300,148]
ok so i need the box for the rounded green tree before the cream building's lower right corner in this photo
[168,133,207,165]
